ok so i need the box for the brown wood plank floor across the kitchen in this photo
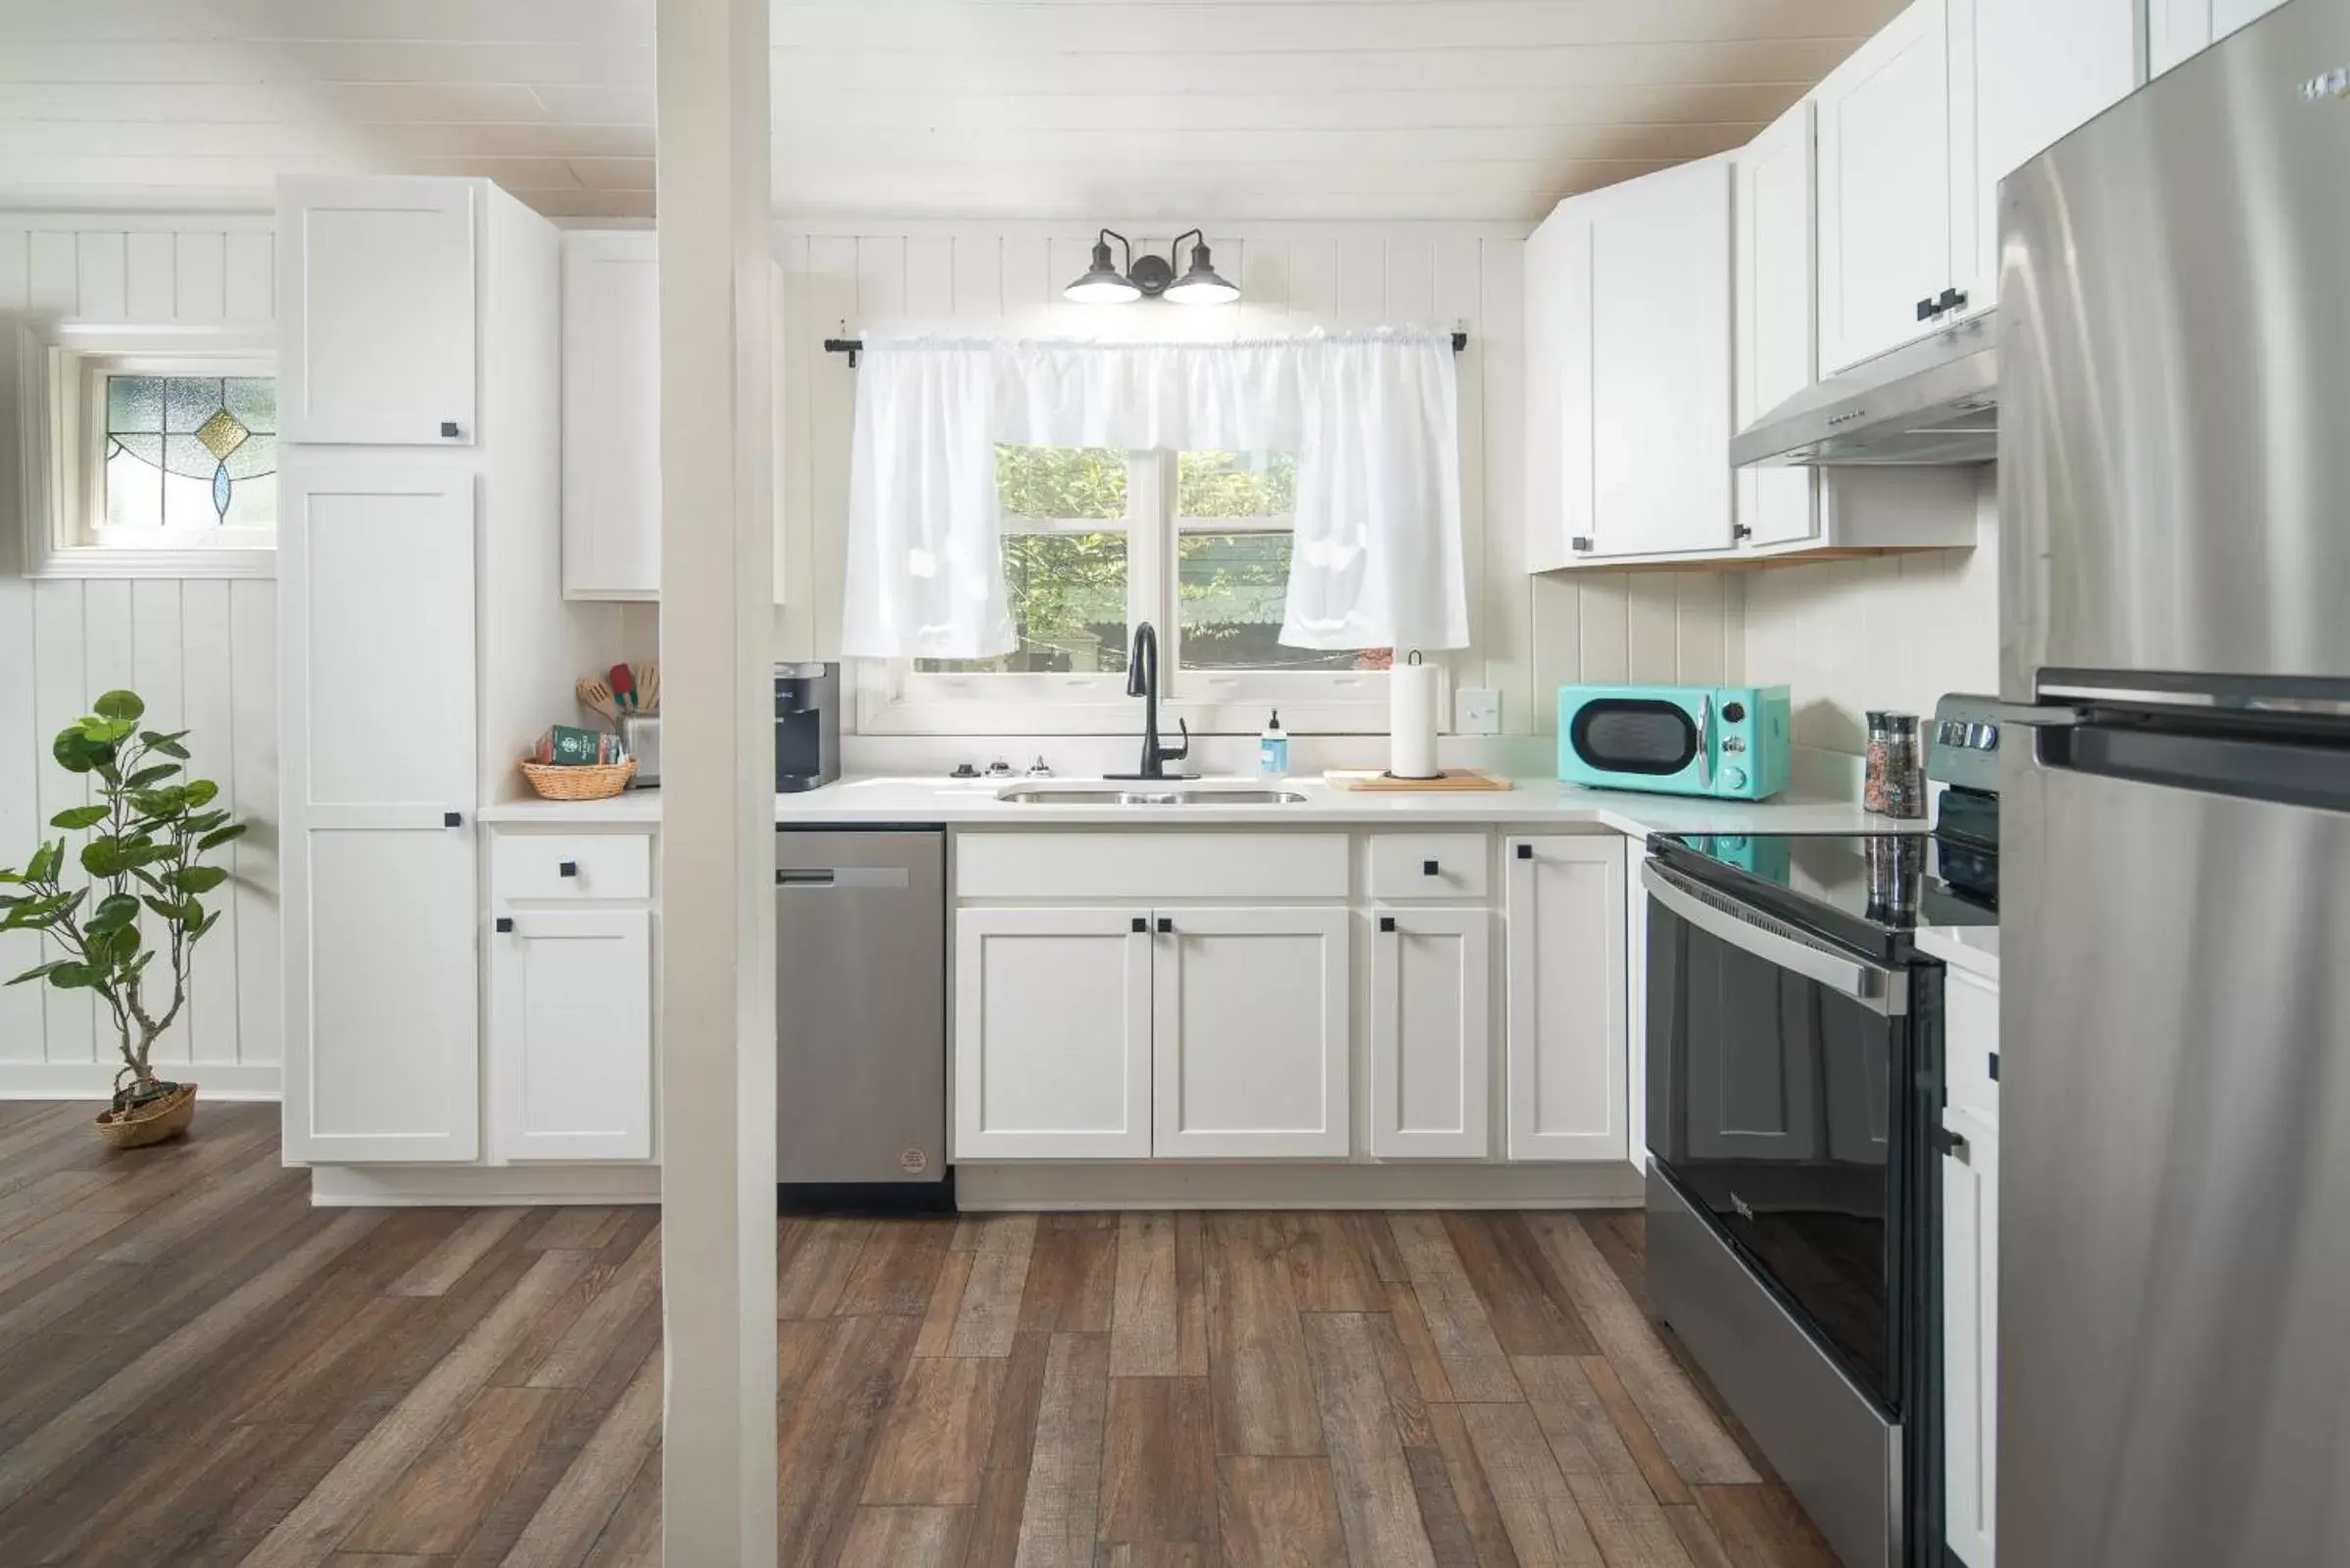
[0,1103,1833,1568]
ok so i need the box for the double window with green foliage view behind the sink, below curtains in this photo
[884,447,1391,734]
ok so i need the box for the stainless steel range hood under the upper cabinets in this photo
[1730,310,2000,468]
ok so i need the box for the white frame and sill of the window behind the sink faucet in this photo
[855,449,1386,736]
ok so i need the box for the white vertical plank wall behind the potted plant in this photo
[0,212,279,1096]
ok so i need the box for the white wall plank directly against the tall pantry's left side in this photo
[223,581,284,1063]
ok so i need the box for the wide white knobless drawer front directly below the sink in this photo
[954,828,1347,903]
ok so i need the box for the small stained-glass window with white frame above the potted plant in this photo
[17,327,277,578]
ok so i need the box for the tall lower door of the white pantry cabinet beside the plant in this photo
[277,463,482,1162]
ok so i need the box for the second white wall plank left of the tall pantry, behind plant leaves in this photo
[177,581,244,1063]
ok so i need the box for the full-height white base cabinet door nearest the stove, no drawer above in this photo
[1507,834,1631,1159]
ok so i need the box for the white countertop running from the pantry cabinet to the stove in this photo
[482,778,1925,837]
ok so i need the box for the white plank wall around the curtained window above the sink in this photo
[776,223,1744,734]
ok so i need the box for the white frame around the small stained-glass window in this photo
[12,322,282,578]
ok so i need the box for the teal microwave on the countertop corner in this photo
[1559,687,1793,799]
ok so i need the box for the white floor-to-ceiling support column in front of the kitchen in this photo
[655,0,776,1568]
